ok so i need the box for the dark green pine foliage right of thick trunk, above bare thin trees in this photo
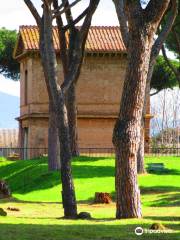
[151,56,179,91]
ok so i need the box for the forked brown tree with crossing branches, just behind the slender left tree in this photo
[53,0,99,156]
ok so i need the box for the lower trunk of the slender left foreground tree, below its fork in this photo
[56,96,77,218]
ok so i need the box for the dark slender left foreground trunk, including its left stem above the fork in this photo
[40,7,77,218]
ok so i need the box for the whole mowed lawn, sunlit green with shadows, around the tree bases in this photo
[0,157,180,240]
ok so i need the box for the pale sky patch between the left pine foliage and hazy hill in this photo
[0,75,20,97]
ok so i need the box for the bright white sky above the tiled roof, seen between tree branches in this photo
[0,0,118,29]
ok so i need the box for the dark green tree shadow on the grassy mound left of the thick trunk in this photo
[0,159,114,194]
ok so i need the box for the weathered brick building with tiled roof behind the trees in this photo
[14,26,150,157]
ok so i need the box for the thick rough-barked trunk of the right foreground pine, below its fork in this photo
[113,26,151,218]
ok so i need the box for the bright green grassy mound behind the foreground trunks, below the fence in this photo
[0,157,180,206]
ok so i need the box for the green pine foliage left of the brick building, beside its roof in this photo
[0,28,20,80]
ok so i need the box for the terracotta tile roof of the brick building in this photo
[15,26,126,56]
